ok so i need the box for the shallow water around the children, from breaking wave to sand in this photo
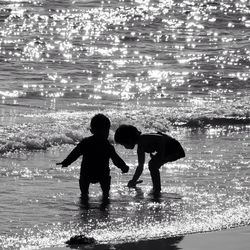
[0,114,250,249]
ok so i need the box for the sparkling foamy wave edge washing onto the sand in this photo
[0,204,249,249]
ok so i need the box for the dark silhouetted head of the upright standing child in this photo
[90,114,111,138]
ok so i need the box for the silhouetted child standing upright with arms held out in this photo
[57,114,129,199]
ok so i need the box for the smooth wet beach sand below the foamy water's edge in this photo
[43,226,250,250]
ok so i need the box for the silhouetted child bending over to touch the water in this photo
[115,125,185,194]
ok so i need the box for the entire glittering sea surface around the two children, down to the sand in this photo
[0,0,250,250]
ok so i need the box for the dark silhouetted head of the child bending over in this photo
[115,124,141,149]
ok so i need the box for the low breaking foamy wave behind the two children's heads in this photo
[0,107,250,155]
